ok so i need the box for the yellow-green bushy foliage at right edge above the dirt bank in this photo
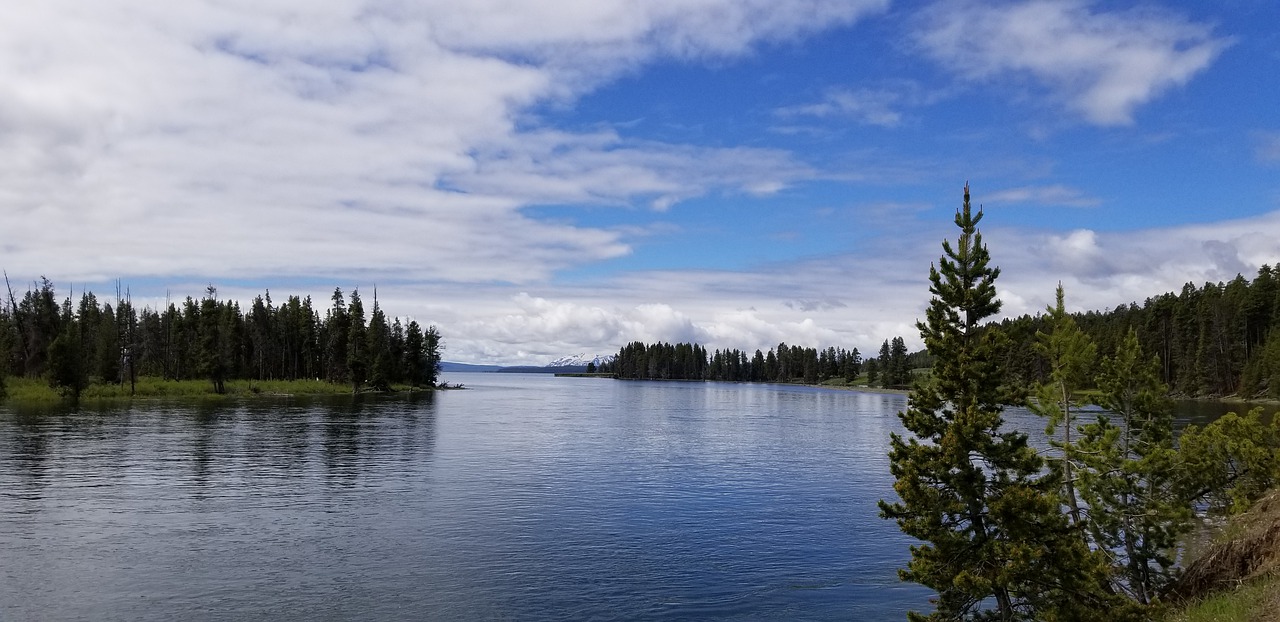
[1179,408,1280,514]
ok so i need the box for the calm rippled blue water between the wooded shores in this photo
[0,374,1264,621]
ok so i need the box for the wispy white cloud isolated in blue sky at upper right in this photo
[918,0,1230,125]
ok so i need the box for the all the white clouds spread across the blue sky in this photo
[0,0,1280,363]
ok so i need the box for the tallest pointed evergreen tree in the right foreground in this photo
[879,187,1114,621]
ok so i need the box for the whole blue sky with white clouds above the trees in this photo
[0,0,1280,363]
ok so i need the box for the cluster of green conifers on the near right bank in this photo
[879,188,1280,621]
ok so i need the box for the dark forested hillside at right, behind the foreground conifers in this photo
[1000,265,1280,398]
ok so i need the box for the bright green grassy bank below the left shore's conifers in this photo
[5,378,430,403]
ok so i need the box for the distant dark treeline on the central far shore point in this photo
[600,342,863,384]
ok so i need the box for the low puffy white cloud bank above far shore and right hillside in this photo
[427,212,1280,363]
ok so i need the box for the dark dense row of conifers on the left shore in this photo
[0,279,442,397]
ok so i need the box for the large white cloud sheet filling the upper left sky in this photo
[0,0,886,283]
